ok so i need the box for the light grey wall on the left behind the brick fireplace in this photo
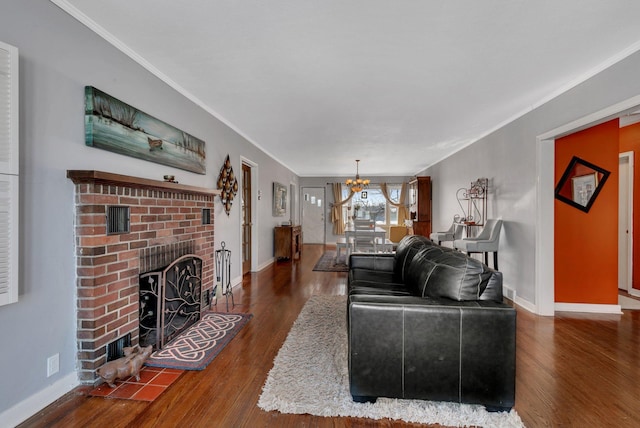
[0,0,298,425]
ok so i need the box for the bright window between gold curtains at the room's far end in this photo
[342,184,402,226]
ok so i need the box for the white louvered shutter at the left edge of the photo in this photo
[0,42,18,305]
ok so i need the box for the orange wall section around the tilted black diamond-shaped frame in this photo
[554,119,620,304]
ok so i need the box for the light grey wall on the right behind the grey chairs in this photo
[420,53,640,310]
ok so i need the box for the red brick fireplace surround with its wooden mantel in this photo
[67,170,219,384]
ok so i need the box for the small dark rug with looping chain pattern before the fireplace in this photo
[145,312,253,370]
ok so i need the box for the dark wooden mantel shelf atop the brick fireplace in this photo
[67,170,220,195]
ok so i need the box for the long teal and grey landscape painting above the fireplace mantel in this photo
[84,86,206,174]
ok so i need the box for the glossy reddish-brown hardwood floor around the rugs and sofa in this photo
[20,245,640,428]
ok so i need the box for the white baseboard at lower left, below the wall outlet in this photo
[0,372,80,427]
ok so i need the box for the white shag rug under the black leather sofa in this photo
[258,296,524,428]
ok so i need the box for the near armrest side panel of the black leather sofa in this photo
[348,295,516,408]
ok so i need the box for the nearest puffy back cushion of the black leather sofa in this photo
[405,246,502,301]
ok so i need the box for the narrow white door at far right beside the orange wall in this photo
[618,152,633,292]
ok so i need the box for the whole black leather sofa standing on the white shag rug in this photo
[347,235,516,411]
